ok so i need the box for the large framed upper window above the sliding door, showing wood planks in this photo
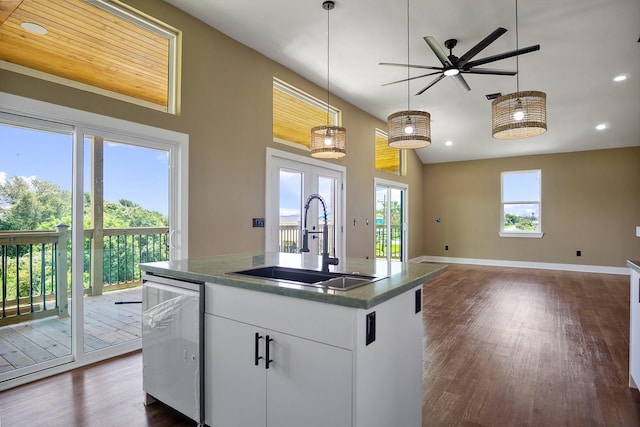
[0,0,181,114]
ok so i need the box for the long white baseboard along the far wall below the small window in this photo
[410,255,630,276]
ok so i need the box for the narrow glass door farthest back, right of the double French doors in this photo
[375,179,407,261]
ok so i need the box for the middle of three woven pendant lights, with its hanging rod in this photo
[387,0,431,149]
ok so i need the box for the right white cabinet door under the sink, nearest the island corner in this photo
[266,331,353,427]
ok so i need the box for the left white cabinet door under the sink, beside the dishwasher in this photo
[205,314,267,427]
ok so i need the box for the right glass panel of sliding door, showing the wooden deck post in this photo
[83,135,169,352]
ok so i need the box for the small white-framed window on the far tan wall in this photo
[500,169,543,237]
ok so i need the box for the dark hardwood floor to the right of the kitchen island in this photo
[423,265,640,426]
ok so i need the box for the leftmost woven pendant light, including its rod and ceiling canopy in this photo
[310,1,347,159]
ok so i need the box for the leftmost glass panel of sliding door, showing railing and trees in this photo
[0,118,75,381]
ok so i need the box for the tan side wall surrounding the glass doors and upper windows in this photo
[0,0,423,258]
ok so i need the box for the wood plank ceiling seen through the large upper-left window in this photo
[0,0,169,107]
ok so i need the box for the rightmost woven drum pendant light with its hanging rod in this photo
[491,0,547,139]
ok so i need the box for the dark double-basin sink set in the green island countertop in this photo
[231,266,378,291]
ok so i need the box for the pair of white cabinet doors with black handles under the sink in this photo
[205,314,352,427]
